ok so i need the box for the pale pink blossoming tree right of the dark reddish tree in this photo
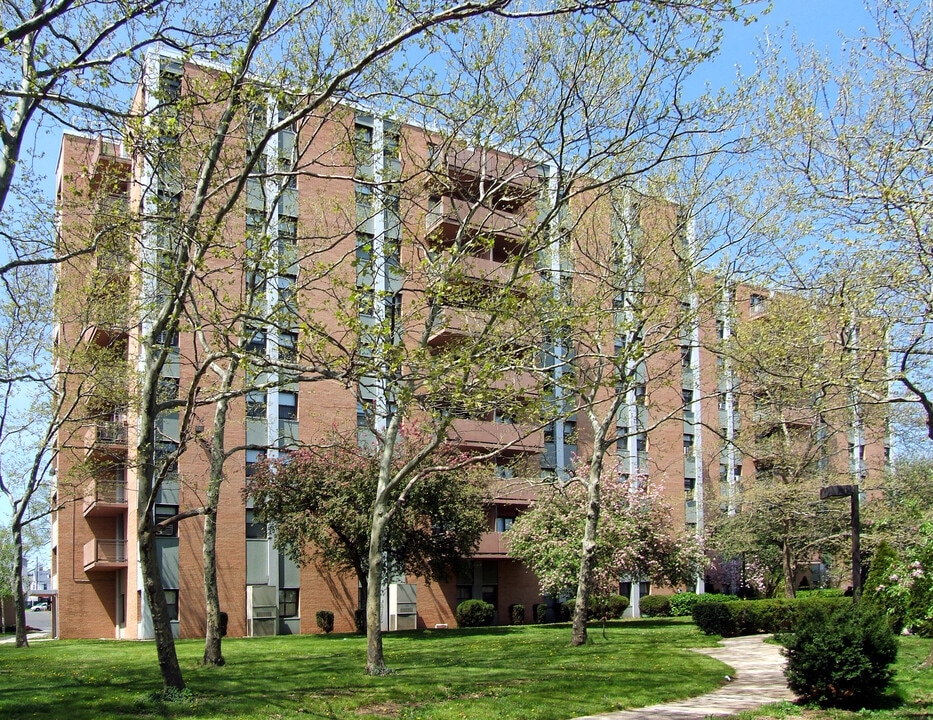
[508,462,705,608]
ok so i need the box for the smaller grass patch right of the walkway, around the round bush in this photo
[736,637,933,720]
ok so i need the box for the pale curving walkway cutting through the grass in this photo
[574,635,794,720]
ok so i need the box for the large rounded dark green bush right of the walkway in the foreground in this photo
[779,603,897,707]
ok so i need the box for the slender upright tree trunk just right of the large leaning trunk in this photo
[201,390,236,665]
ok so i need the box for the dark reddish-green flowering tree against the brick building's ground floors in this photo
[245,427,489,624]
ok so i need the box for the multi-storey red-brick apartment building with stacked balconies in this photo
[52,50,885,638]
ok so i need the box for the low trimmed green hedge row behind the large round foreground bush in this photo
[693,597,852,637]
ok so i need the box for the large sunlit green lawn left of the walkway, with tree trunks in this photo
[0,619,725,720]
